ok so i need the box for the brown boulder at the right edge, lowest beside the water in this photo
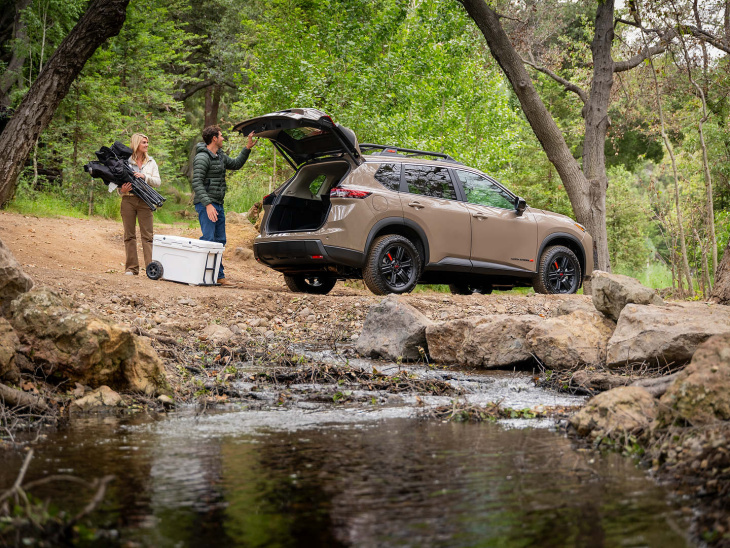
[660,333,730,425]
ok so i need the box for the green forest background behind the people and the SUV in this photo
[0,0,730,298]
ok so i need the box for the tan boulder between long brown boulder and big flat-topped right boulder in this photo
[527,309,615,369]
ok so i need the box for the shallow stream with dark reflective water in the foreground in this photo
[0,356,689,548]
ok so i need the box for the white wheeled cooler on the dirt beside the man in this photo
[147,235,224,285]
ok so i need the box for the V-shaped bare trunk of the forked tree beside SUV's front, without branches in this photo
[460,0,613,270]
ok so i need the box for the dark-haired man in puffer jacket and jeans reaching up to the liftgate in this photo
[193,126,258,286]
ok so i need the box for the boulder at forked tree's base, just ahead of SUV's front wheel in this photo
[591,270,664,321]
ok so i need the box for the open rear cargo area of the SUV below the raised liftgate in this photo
[267,161,350,234]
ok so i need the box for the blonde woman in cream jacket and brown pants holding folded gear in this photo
[119,133,161,276]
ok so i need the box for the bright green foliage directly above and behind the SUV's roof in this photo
[232,0,522,175]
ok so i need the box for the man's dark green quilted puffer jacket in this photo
[193,143,251,206]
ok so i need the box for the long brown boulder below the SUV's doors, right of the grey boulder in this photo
[426,314,544,368]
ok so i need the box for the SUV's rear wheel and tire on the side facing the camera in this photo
[362,234,421,295]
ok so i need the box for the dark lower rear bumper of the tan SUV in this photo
[253,240,365,272]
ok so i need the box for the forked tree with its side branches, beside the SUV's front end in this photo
[460,0,665,270]
